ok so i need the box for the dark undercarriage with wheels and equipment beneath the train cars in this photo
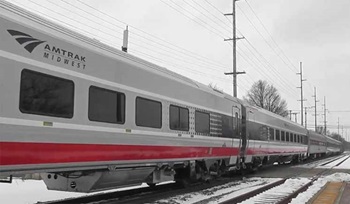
[40,155,304,193]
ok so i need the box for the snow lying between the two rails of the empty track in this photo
[241,178,310,204]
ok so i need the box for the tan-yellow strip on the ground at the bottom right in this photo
[309,182,346,204]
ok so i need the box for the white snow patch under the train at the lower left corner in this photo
[0,178,147,204]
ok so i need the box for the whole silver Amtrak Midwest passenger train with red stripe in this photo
[0,0,341,192]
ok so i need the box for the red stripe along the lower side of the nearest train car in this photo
[0,142,239,166]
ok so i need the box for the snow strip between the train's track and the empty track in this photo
[155,178,280,204]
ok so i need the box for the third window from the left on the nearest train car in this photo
[136,97,162,128]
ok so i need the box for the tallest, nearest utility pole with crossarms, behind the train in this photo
[224,0,245,97]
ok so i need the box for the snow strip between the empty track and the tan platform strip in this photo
[290,173,350,204]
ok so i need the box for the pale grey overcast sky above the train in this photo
[8,0,350,138]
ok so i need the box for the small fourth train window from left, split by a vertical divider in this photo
[169,105,189,131]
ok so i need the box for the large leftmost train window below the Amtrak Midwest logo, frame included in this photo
[19,69,74,118]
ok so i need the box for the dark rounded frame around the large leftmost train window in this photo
[18,68,75,119]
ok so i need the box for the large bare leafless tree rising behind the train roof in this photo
[244,80,288,117]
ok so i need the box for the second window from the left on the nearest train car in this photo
[88,86,125,124]
